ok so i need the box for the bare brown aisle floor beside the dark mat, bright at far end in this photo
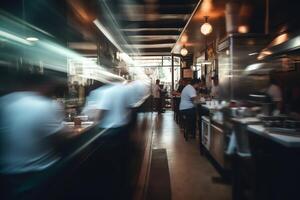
[152,111,231,200]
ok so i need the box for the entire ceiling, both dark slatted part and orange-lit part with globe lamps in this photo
[67,0,263,56]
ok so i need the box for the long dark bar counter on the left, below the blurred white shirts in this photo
[1,102,152,199]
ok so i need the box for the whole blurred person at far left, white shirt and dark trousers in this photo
[0,74,65,199]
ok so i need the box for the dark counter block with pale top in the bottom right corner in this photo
[247,125,300,200]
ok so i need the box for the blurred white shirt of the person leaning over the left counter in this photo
[82,81,147,129]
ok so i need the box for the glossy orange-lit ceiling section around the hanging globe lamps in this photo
[172,0,265,57]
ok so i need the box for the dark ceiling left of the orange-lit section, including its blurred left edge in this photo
[68,0,199,56]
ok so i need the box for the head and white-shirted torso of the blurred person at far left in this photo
[0,75,64,174]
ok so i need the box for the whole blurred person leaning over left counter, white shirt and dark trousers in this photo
[85,81,147,199]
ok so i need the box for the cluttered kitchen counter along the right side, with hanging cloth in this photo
[197,98,300,200]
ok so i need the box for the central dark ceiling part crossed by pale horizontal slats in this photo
[116,0,198,55]
